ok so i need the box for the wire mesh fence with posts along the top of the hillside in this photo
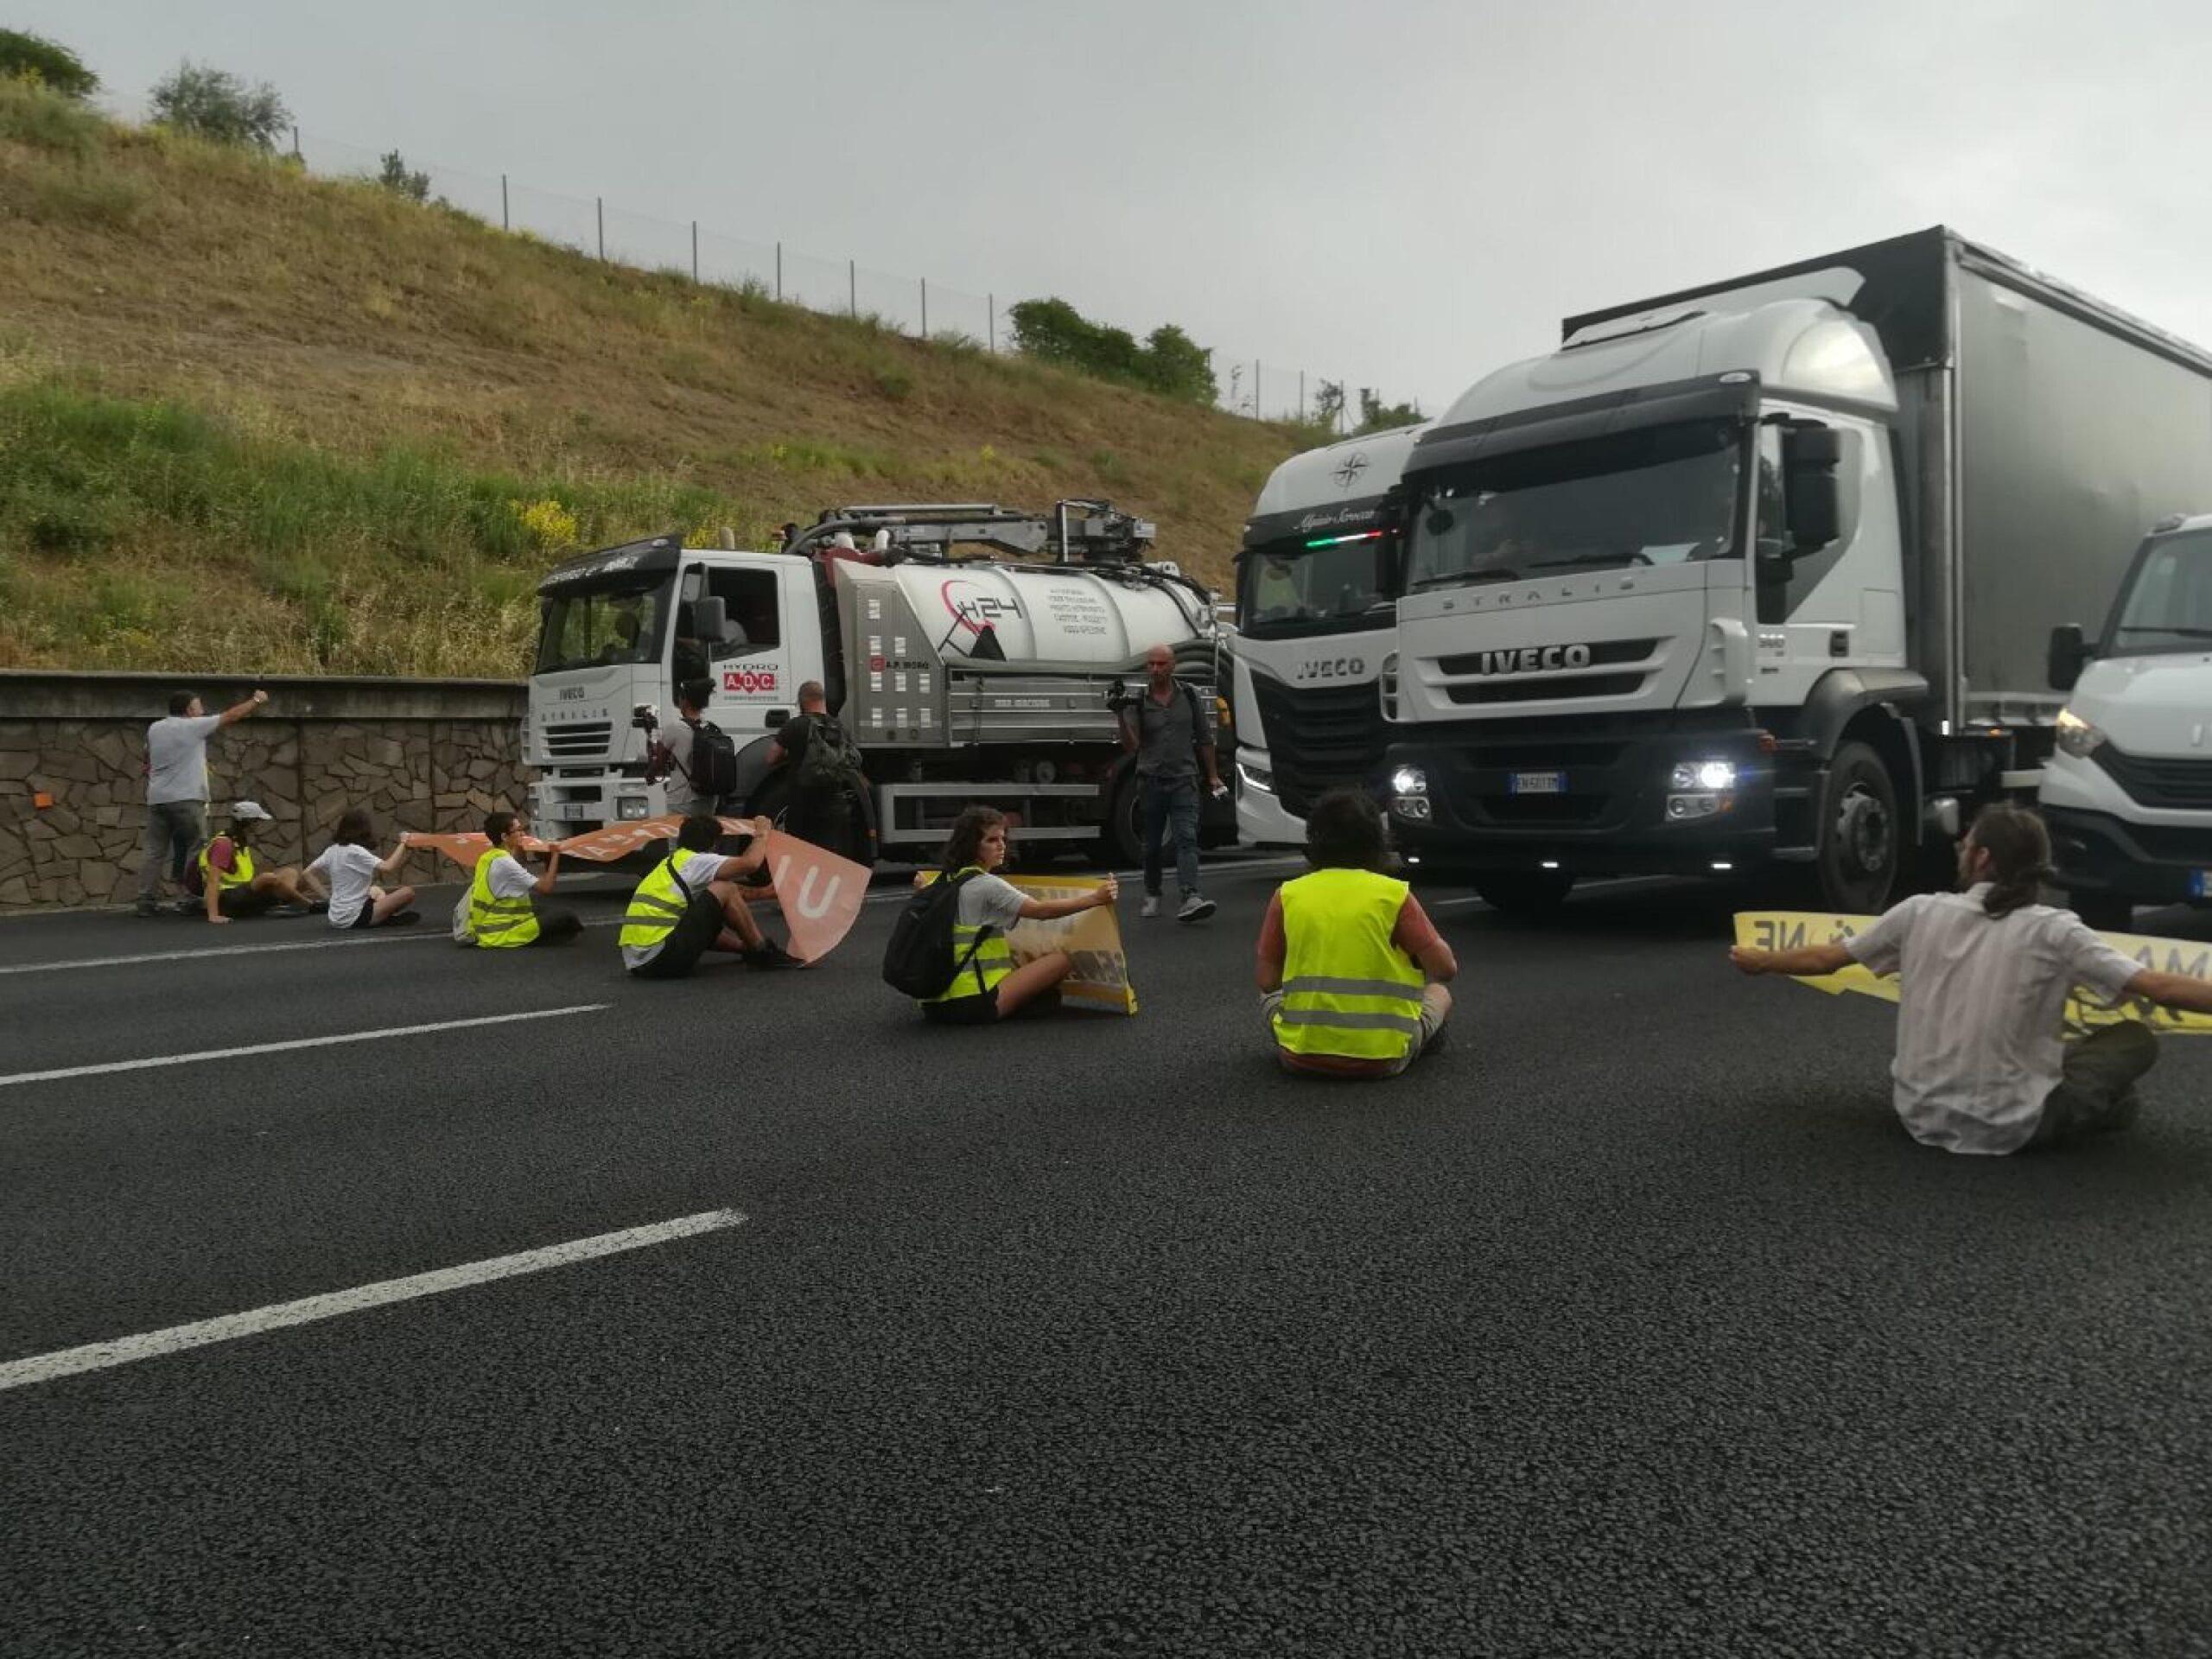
[292,130,1397,431]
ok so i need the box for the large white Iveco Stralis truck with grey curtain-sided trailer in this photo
[1380,228,2212,912]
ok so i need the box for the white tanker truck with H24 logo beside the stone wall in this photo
[524,502,1236,865]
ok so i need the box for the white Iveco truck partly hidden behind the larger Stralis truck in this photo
[1232,427,1422,845]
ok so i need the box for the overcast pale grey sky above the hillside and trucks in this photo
[30,0,2212,411]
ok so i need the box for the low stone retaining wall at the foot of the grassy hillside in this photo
[0,672,526,912]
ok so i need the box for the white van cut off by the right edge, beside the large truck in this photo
[2039,513,2212,929]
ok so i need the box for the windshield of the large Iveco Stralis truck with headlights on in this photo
[1407,420,1745,588]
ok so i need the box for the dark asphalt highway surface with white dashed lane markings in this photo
[0,862,2212,1656]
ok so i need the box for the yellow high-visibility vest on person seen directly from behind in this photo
[1272,869,1425,1059]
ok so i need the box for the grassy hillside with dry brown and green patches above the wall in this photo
[0,86,1310,675]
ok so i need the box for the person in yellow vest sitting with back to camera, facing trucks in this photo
[1256,790,1460,1077]
